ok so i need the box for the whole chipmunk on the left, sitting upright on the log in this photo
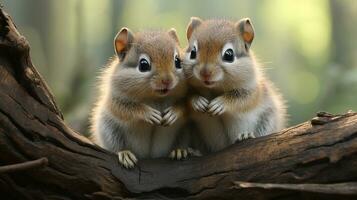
[91,28,187,168]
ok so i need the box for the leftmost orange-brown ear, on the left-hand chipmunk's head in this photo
[114,27,134,59]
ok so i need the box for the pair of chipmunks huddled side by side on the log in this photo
[91,17,286,168]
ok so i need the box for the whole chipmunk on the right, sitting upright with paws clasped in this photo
[183,17,286,152]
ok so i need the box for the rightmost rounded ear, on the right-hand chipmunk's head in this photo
[236,18,254,49]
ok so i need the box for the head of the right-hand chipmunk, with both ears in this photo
[183,17,255,88]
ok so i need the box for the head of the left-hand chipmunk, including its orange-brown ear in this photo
[112,28,184,97]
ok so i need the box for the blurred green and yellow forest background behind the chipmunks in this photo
[0,0,357,133]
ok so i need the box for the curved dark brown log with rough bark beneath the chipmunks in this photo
[0,7,357,200]
